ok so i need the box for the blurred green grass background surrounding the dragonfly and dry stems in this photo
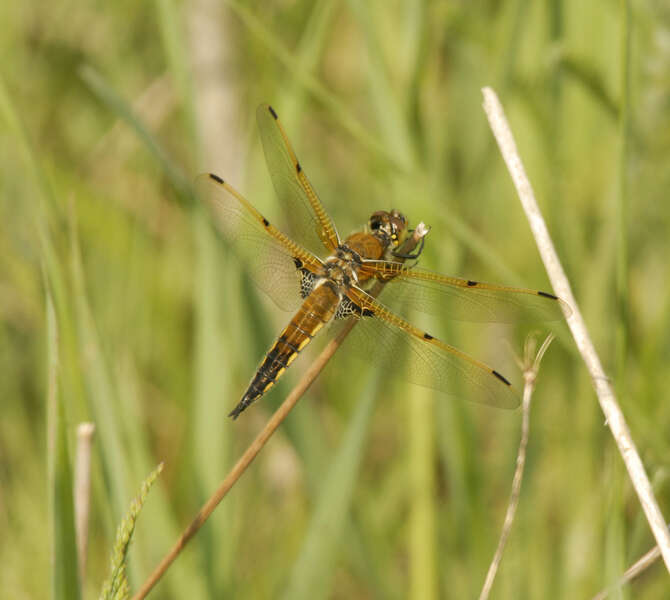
[0,0,670,599]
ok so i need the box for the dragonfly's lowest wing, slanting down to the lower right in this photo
[344,288,519,408]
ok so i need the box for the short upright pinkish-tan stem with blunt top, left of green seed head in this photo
[74,423,95,588]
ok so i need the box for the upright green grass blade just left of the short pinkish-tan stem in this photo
[46,288,81,600]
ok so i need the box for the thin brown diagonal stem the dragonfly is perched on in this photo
[132,223,429,600]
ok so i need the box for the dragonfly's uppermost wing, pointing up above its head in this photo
[256,104,340,256]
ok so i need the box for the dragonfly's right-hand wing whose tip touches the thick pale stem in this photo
[363,261,571,323]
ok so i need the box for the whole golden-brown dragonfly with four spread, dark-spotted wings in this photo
[196,104,569,419]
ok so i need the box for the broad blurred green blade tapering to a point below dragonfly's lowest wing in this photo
[283,386,375,600]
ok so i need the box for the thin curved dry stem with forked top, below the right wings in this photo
[479,334,554,600]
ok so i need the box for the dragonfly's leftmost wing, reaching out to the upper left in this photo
[196,173,321,311]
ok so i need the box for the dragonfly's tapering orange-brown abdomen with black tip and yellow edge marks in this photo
[228,282,340,419]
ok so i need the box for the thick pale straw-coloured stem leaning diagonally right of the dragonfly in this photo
[482,87,670,571]
